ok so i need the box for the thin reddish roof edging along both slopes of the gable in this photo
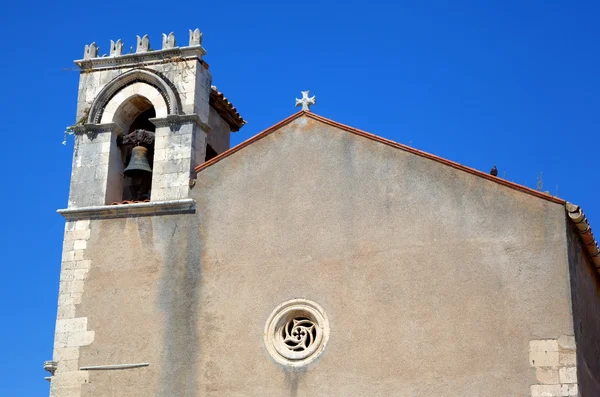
[194,110,566,205]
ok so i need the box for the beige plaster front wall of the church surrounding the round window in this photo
[72,113,585,397]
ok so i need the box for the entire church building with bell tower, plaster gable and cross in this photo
[44,30,600,397]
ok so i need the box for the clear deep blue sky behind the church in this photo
[0,0,600,396]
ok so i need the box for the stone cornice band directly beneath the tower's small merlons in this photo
[75,45,206,71]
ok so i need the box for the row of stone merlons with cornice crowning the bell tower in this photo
[75,29,206,70]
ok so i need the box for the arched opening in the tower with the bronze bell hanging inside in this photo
[114,95,156,203]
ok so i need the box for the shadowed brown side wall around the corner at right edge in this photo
[568,223,600,396]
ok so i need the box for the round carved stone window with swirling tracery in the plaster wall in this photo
[265,299,329,367]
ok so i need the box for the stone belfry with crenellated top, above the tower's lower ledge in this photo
[62,29,244,210]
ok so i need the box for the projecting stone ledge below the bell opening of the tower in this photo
[57,199,196,221]
